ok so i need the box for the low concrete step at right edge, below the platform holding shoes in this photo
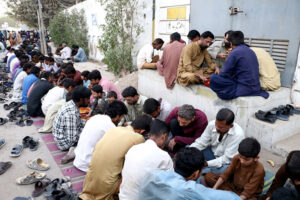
[272,133,300,157]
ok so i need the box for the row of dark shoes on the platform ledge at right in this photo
[255,104,300,124]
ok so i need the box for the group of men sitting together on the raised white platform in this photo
[137,30,281,100]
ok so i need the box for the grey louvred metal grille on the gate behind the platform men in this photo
[215,36,289,71]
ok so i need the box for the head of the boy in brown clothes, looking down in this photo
[238,138,260,167]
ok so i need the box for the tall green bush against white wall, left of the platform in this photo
[99,0,143,75]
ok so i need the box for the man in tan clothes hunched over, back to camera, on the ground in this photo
[80,115,152,200]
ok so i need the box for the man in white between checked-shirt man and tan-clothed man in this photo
[73,101,127,172]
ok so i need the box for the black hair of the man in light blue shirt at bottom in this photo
[175,147,205,178]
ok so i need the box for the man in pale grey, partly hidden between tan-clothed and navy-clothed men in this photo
[207,30,232,69]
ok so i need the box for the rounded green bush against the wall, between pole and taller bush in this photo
[49,9,89,55]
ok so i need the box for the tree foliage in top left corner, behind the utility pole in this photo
[6,0,84,28]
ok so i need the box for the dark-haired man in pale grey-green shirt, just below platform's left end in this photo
[122,86,147,124]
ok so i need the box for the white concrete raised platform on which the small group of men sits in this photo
[138,70,300,155]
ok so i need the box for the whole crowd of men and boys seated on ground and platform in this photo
[1,31,300,200]
